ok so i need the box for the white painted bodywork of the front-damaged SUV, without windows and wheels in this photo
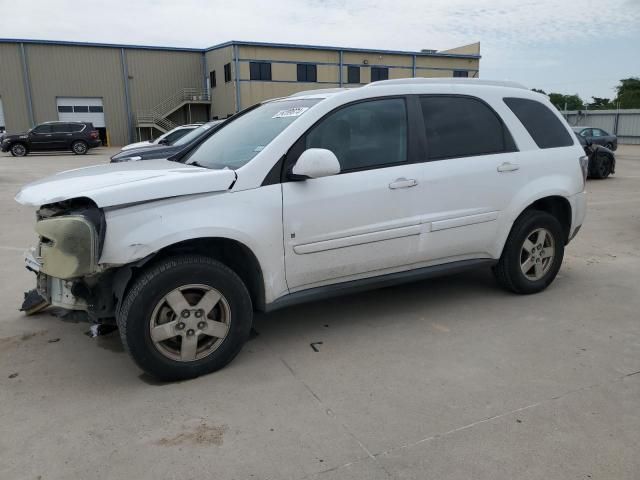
[16,80,586,303]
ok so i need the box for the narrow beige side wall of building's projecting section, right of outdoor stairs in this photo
[205,46,236,118]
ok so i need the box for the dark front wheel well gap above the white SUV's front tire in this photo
[144,238,265,311]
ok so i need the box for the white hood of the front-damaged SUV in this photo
[16,160,236,207]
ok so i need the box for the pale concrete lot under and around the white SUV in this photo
[0,147,640,480]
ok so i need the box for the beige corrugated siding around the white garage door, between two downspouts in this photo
[25,45,128,145]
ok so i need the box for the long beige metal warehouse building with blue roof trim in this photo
[0,39,480,145]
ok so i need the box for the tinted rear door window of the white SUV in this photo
[420,95,516,160]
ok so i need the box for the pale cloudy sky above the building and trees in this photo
[0,0,640,100]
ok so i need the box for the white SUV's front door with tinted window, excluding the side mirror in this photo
[282,98,422,291]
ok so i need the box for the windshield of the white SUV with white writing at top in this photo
[185,98,321,169]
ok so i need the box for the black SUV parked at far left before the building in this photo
[2,122,102,157]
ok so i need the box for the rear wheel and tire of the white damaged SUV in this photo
[493,210,565,294]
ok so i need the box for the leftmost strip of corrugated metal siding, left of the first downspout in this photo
[0,43,31,133]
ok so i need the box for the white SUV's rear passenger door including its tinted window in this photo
[420,95,526,261]
